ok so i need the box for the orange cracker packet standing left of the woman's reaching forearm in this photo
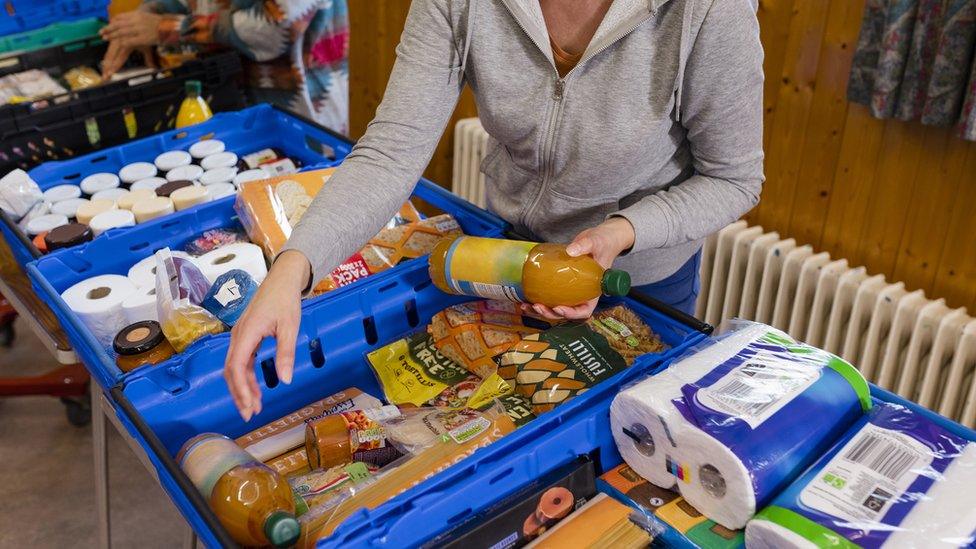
[234,168,335,261]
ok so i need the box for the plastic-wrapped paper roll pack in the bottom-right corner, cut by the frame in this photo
[746,403,976,549]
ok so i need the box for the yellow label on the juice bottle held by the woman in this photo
[444,236,536,302]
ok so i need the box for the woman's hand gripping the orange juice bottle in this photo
[522,217,635,321]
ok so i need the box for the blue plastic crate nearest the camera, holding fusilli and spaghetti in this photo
[113,265,704,546]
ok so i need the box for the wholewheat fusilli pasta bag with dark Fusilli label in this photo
[498,305,667,414]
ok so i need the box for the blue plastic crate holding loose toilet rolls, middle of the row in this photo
[27,173,504,389]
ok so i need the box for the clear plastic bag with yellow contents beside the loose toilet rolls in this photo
[156,248,224,353]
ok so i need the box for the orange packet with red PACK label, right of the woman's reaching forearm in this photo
[312,208,462,295]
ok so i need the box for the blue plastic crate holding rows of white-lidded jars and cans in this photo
[0,105,352,266]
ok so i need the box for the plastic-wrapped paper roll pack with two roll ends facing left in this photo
[610,321,871,530]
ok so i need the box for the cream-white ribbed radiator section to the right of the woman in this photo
[696,221,976,428]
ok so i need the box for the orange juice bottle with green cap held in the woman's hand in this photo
[430,236,630,307]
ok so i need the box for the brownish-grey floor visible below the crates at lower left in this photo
[0,314,186,548]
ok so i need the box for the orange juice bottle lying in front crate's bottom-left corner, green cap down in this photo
[176,433,301,547]
